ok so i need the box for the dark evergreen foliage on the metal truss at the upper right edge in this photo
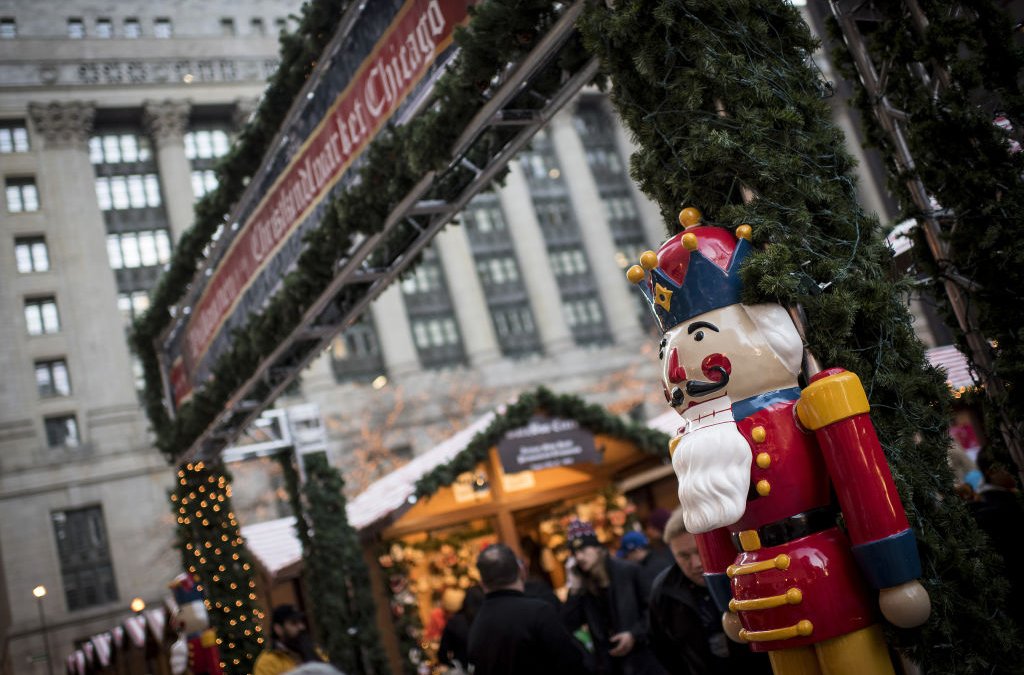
[833,0,1024,470]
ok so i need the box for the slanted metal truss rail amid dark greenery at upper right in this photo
[829,0,1024,471]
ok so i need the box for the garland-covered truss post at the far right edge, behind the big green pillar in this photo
[831,0,1024,472]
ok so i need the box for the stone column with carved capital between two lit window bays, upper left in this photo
[144,100,196,242]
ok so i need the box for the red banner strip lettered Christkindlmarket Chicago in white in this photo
[163,0,472,408]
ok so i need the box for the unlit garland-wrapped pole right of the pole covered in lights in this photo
[302,453,385,675]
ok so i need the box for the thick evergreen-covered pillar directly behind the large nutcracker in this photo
[581,0,1021,674]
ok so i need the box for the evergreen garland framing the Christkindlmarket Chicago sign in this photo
[132,0,588,461]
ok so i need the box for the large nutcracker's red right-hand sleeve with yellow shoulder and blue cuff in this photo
[797,368,928,624]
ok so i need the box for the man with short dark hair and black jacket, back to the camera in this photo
[469,544,587,675]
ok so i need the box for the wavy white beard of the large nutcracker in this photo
[672,417,751,534]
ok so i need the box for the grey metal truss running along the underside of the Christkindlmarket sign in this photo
[177,0,598,462]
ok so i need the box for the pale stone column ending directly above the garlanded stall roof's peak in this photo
[498,162,572,355]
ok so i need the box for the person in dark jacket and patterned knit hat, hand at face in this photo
[562,520,665,675]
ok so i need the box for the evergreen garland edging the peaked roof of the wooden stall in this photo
[415,387,669,499]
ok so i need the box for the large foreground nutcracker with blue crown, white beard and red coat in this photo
[627,208,931,675]
